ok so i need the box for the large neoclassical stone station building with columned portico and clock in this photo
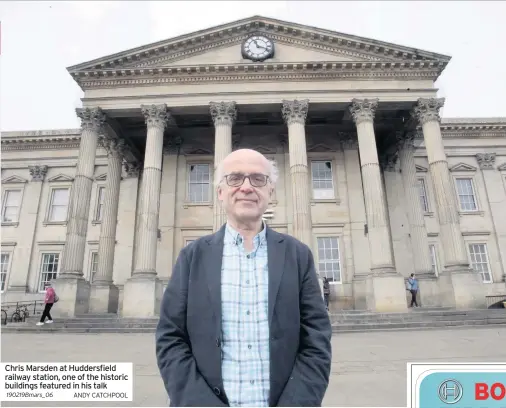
[1,16,506,317]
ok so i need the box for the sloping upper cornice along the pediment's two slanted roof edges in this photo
[68,16,450,73]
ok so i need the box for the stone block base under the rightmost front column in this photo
[439,267,487,309]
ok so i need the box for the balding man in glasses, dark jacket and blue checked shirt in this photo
[156,149,331,407]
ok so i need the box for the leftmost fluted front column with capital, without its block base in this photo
[60,108,106,278]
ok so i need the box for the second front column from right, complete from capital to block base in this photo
[350,99,407,311]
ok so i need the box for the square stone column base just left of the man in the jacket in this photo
[121,275,163,318]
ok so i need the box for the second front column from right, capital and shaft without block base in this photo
[350,99,395,273]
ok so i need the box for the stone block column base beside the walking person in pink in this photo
[51,276,90,317]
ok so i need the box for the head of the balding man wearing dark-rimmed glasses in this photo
[215,149,278,224]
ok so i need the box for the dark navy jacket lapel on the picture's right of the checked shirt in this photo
[267,227,286,326]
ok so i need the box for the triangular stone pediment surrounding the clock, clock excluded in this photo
[68,16,450,76]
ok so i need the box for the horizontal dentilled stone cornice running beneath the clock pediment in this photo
[74,61,444,89]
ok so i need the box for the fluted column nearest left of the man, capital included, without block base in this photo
[133,105,169,276]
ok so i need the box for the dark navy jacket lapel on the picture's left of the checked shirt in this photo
[201,226,225,333]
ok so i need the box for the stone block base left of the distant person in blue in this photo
[367,272,408,312]
